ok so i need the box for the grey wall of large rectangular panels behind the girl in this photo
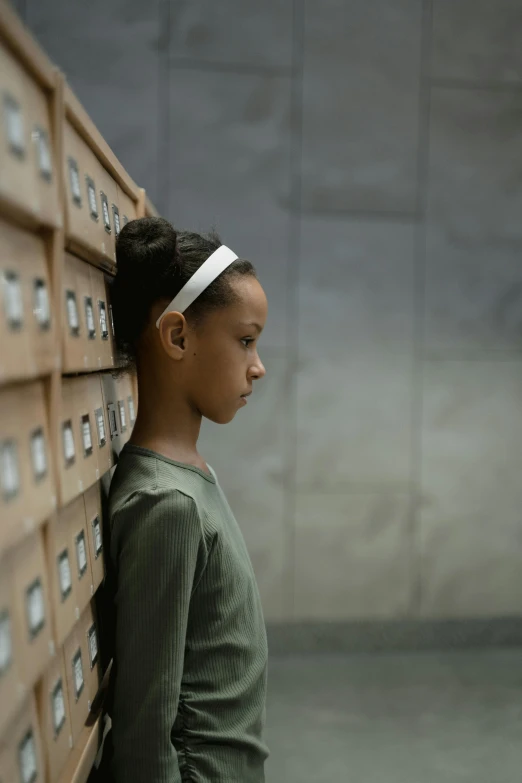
[25,0,522,621]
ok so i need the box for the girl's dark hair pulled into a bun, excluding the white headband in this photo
[111,217,256,367]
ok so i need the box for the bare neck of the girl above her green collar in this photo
[130,363,202,464]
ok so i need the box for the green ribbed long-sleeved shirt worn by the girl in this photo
[109,445,268,783]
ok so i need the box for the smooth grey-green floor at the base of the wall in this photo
[266,650,522,783]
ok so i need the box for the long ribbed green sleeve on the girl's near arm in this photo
[111,490,207,783]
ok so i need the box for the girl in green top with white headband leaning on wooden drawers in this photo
[102,218,267,783]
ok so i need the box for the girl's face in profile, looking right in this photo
[184,277,268,424]
